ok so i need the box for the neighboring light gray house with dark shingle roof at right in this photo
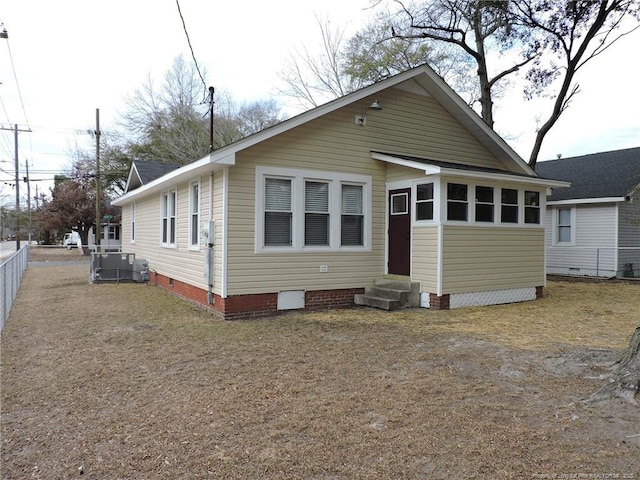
[536,147,640,277]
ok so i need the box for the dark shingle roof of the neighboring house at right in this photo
[536,147,640,202]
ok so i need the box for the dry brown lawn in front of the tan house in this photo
[1,249,640,480]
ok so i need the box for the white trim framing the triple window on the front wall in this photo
[255,167,372,253]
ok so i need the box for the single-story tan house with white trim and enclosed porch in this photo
[113,66,568,319]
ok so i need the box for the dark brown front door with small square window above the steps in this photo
[388,188,411,275]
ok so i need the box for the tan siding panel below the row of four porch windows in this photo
[442,226,545,294]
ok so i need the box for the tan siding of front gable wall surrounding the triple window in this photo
[227,90,510,295]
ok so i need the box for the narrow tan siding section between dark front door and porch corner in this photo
[411,226,438,293]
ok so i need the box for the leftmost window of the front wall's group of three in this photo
[264,178,292,247]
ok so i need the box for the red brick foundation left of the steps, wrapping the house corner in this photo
[150,273,364,320]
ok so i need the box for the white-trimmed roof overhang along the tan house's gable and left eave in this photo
[113,65,537,205]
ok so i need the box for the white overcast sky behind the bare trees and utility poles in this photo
[0,0,640,199]
